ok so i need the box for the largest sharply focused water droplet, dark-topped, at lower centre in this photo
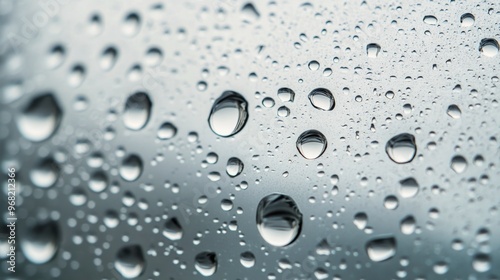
[257,194,302,247]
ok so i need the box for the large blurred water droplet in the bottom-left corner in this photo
[21,221,60,264]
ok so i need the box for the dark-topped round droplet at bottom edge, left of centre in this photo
[114,245,146,279]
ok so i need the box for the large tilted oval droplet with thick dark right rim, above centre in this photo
[208,91,248,137]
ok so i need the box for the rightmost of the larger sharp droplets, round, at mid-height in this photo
[385,133,417,164]
